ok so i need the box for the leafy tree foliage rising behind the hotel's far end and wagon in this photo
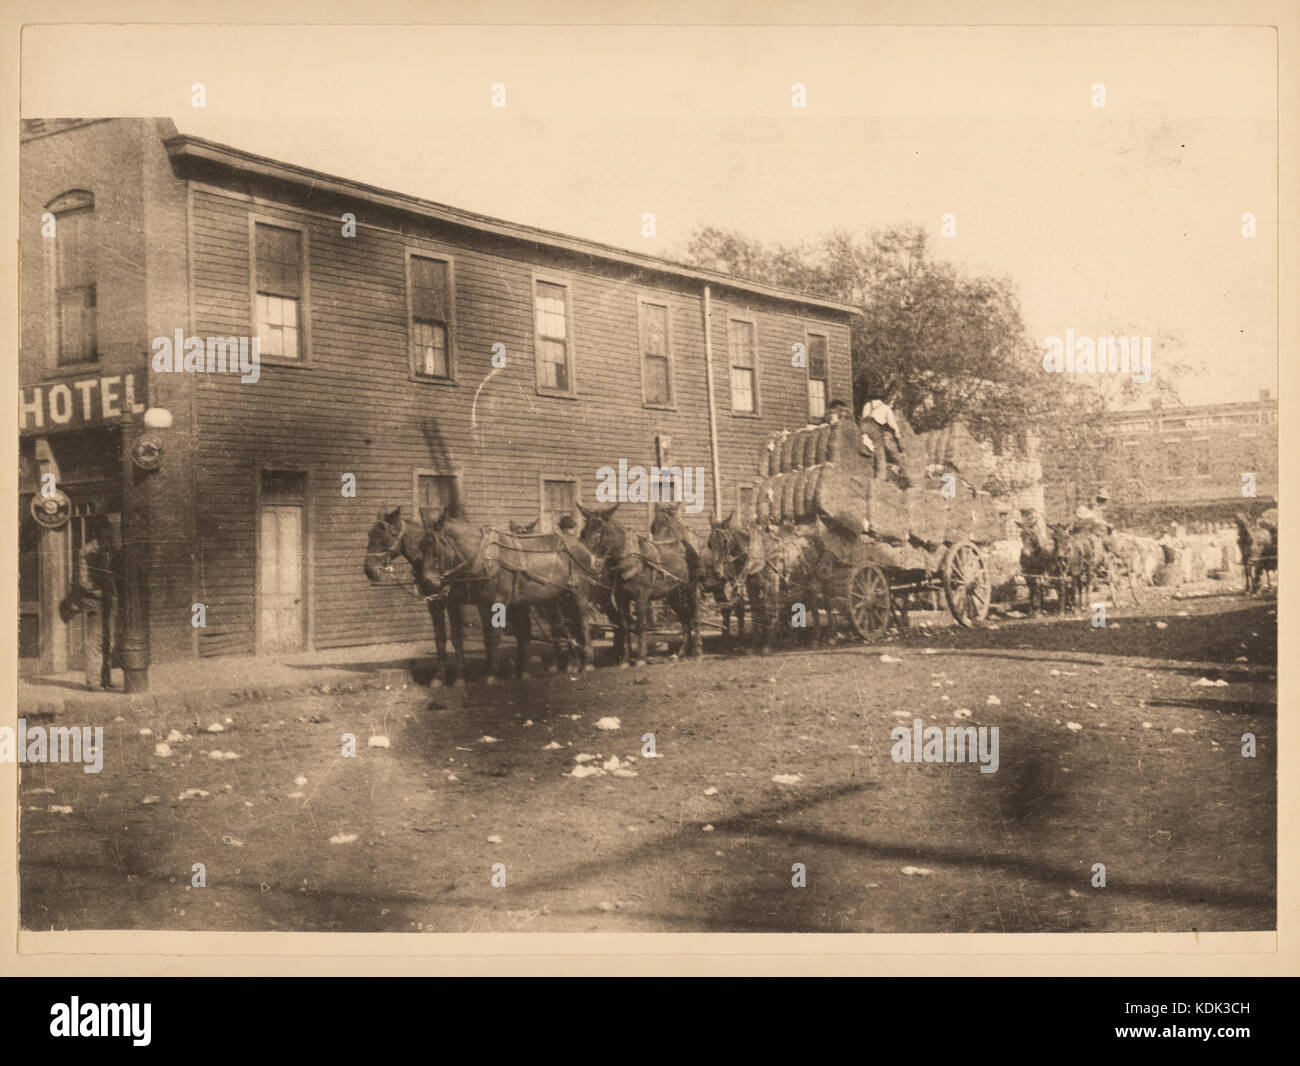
[684,226,1188,511]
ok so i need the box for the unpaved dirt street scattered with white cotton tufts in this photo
[20,590,1277,932]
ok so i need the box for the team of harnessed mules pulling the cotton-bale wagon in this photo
[364,504,863,685]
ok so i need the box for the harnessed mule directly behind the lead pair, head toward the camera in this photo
[579,503,705,667]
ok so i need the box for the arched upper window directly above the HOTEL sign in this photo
[48,190,99,367]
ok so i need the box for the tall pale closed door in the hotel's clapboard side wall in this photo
[257,471,307,651]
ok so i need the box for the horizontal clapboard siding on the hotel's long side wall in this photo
[185,186,849,654]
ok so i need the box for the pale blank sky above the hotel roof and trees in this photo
[22,26,1278,403]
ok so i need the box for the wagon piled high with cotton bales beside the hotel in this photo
[755,417,1000,640]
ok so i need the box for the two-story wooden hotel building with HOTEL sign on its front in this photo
[20,118,854,671]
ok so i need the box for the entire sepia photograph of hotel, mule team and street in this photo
[10,20,1294,940]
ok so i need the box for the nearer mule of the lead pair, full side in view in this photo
[420,511,598,685]
